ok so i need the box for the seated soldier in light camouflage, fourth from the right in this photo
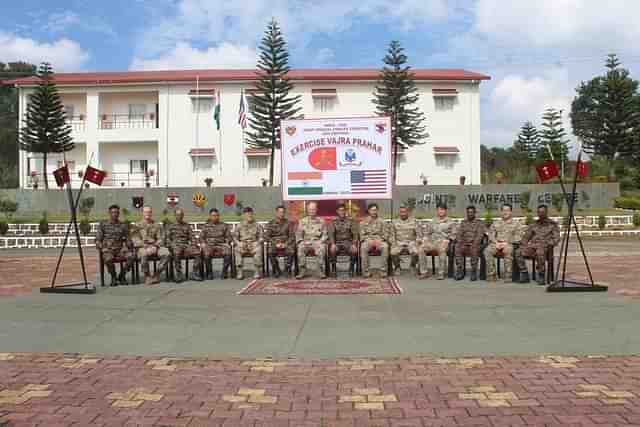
[420,203,456,280]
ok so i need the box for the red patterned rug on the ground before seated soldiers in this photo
[238,278,402,295]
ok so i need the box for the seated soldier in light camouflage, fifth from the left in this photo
[233,206,263,280]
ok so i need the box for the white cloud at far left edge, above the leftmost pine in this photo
[0,32,89,71]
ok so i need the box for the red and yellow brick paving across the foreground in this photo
[0,353,640,427]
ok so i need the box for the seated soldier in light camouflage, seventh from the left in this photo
[296,202,327,279]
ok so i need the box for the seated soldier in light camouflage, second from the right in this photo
[484,203,521,282]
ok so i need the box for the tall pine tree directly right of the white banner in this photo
[372,40,429,182]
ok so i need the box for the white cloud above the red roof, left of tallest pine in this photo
[129,42,258,70]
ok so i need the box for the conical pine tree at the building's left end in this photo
[19,62,74,190]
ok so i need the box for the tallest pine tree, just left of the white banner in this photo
[247,20,302,185]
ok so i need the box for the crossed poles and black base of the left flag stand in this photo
[40,160,96,295]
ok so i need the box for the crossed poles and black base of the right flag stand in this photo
[547,147,609,292]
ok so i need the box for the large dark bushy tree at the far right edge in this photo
[571,54,640,167]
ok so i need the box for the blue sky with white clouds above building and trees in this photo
[0,0,640,152]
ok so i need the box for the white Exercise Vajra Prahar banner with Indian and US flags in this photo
[281,117,393,200]
